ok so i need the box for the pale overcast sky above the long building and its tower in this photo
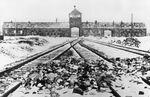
[0,0,150,29]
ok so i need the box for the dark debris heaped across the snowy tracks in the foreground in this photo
[2,36,149,97]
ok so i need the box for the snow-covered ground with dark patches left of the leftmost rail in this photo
[0,36,73,68]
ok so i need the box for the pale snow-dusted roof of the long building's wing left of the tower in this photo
[3,22,69,28]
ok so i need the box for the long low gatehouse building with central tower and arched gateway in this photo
[3,7,146,37]
